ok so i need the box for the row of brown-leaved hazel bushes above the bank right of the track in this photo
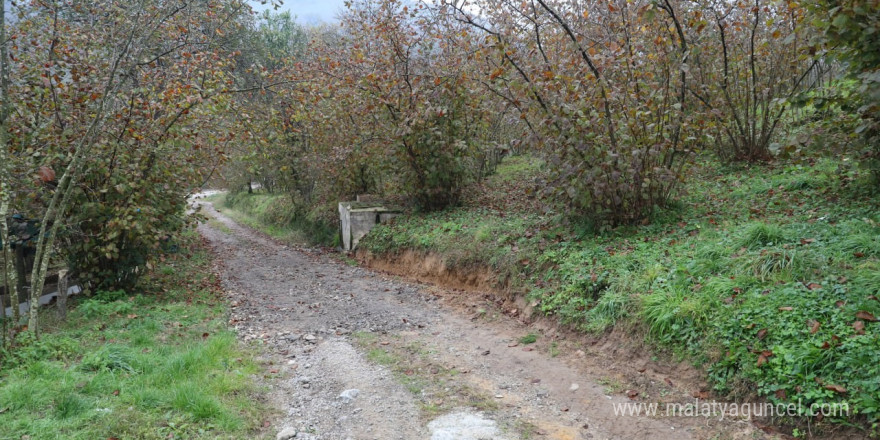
[227,0,852,225]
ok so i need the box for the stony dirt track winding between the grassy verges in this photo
[199,200,763,440]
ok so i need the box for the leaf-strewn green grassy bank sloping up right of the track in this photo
[361,158,880,434]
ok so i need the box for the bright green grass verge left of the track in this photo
[0,232,267,439]
